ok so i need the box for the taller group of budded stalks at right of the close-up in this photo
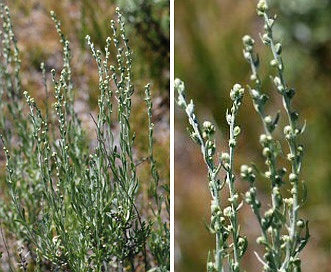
[241,0,309,271]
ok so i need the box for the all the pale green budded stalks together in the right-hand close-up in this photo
[175,0,309,272]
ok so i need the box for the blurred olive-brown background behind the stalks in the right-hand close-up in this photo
[175,0,331,272]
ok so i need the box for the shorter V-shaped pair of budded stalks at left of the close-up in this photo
[175,79,247,272]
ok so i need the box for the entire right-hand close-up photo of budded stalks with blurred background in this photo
[174,0,331,271]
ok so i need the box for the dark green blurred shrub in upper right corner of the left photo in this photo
[118,0,170,91]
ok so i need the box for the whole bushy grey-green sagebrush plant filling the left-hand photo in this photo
[0,5,170,271]
